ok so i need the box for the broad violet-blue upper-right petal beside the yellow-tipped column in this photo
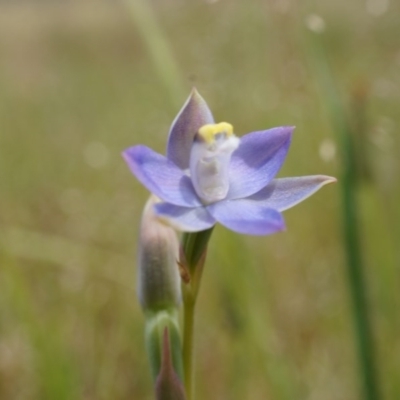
[227,126,294,199]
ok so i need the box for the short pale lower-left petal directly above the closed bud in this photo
[154,203,216,232]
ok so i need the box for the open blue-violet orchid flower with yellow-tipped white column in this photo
[123,89,336,235]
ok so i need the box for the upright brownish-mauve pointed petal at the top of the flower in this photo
[167,89,214,169]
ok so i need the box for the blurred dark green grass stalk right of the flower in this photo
[306,32,380,400]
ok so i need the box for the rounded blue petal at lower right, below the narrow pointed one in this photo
[207,199,285,235]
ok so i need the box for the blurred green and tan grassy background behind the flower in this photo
[0,0,400,400]
